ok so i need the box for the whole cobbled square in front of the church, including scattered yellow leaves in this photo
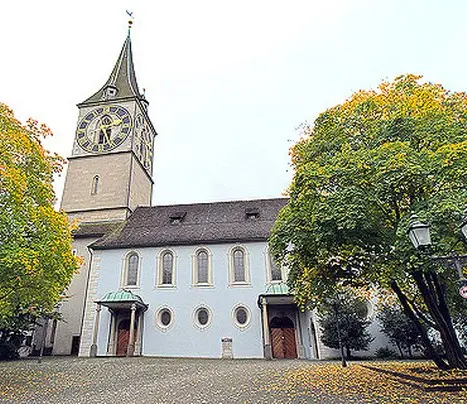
[0,357,467,404]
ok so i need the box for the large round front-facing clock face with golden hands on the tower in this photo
[76,105,132,153]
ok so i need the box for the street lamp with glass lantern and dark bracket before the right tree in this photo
[407,210,467,297]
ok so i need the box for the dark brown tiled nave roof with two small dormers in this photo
[91,198,288,249]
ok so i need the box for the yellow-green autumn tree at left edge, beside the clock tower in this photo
[0,103,78,329]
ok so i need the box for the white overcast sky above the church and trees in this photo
[0,0,467,204]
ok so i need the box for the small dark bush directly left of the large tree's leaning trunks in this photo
[376,304,421,358]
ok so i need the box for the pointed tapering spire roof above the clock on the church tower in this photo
[81,30,144,104]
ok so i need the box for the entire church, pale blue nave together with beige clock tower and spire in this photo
[51,26,388,359]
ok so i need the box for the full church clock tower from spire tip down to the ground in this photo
[51,25,156,355]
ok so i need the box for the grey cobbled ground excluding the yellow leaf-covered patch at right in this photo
[0,357,340,404]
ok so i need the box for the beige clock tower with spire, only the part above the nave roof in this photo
[61,31,156,222]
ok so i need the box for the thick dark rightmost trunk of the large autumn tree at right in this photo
[412,271,467,369]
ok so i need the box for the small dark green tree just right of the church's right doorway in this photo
[318,292,373,358]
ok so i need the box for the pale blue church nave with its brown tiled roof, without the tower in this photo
[80,198,317,358]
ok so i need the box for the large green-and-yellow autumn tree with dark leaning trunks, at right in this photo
[270,75,467,369]
